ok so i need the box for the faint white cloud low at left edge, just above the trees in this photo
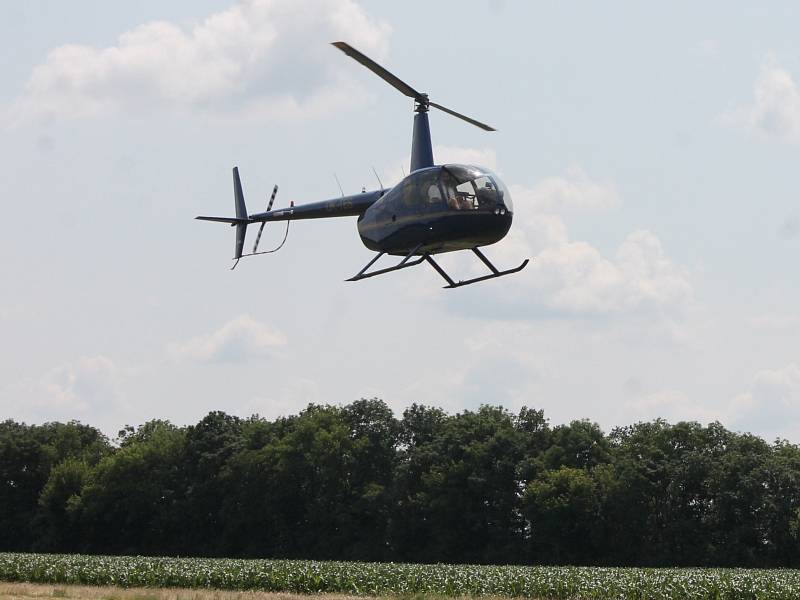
[0,356,125,421]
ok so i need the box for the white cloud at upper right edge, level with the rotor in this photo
[720,56,800,142]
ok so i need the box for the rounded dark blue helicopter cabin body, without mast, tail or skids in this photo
[358,165,513,255]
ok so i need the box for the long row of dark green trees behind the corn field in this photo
[0,399,800,567]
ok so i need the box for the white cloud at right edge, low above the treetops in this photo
[732,363,800,440]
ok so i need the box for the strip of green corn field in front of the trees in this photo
[0,553,800,600]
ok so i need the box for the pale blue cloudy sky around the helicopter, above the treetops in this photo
[0,0,800,443]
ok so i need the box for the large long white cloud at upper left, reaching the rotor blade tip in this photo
[6,0,390,118]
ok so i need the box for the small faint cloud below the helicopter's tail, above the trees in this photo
[168,315,286,363]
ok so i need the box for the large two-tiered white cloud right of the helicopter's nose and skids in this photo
[476,162,694,320]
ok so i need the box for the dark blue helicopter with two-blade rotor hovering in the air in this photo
[196,42,529,288]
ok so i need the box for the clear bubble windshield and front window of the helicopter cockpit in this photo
[441,165,514,214]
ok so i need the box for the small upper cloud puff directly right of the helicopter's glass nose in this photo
[511,166,620,212]
